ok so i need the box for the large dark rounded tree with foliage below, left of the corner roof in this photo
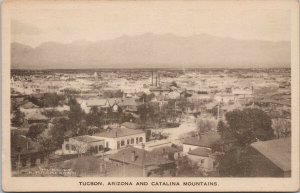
[215,109,274,176]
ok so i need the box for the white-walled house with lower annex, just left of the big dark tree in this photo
[183,131,220,172]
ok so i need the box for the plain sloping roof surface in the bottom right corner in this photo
[251,137,291,171]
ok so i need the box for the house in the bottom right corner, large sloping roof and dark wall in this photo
[250,137,291,177]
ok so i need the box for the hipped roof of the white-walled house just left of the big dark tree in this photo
[183,131,221,148]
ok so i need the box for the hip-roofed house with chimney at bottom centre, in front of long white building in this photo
[109,146,176,177]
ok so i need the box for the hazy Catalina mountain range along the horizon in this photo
[11,33,291,69]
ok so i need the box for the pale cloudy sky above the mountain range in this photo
[11,1,291,47]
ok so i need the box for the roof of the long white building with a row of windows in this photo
[93,127,145,138]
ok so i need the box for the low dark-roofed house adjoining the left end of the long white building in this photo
[62,135,105,154]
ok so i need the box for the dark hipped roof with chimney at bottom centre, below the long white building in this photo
[109,146,174,166]
